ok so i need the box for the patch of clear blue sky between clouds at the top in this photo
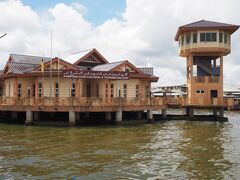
[22,0,126,25]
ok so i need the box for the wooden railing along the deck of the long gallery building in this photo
[0,97,163,107]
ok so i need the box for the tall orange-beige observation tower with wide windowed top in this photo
[175,20,239,115]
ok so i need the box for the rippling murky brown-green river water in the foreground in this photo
[0,113,240,179]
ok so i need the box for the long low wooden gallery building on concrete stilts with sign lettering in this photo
[0,49,163,125]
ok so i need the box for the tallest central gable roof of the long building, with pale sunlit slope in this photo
[64,49,108,65]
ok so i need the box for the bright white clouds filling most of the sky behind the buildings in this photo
[0,0,240,85]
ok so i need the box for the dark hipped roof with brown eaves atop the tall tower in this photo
[175,20,239,41]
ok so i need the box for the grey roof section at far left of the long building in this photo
[9,54,51,64]
